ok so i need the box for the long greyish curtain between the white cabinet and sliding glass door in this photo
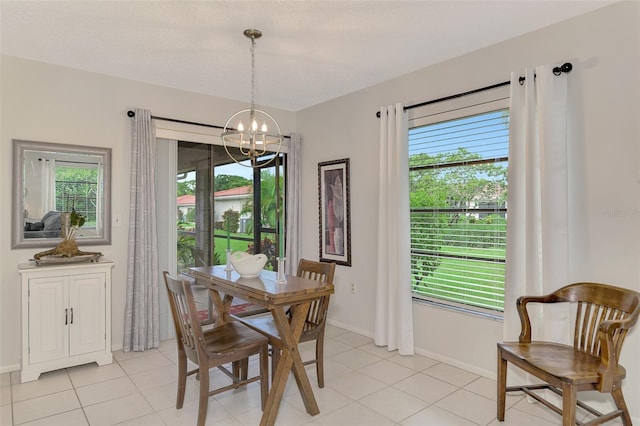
[123,109,160,352]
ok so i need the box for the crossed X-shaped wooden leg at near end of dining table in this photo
[260,303,320,426]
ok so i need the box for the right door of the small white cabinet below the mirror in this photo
[69,273,106,356]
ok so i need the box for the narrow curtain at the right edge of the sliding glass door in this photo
[285,133,301,275]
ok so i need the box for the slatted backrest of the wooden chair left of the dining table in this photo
[163,271,204,363]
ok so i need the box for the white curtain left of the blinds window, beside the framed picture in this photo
[374,104,414,355]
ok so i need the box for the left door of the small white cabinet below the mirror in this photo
[28,277,69,364]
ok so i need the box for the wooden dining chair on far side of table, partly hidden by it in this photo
[241,259,336,388]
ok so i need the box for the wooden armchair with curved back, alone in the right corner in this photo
[497,283,640,426]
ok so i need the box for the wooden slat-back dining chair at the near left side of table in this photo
[163,271,269,426]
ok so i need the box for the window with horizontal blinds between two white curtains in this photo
[409,104,509,313]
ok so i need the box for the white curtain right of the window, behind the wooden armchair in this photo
[504,66,576,341]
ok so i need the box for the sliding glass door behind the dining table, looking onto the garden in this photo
[156,139,286,339]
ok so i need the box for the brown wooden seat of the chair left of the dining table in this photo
[204,322,269,356]
